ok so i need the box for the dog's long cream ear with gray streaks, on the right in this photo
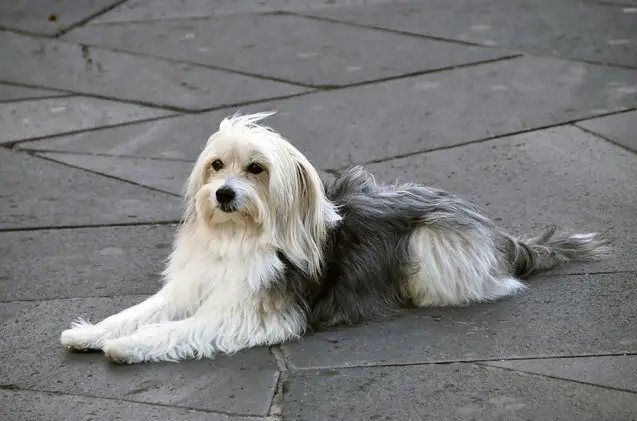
[282,151,341,275]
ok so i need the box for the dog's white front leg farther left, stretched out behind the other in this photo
[60,285,186,351]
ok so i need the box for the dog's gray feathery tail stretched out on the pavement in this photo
[508,227,609,278]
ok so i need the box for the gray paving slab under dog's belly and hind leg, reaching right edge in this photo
[284,272,637,369]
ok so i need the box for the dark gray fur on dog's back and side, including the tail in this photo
[274,167,605,329]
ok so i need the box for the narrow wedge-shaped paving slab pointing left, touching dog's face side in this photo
[39,152,194,195]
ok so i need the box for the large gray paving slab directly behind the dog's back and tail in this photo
[368,126,637,274]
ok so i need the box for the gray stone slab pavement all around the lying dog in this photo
[0,0,637,421]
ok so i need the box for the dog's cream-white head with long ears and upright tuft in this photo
[185,113,340,273]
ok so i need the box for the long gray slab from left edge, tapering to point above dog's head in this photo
[0,32,306,110]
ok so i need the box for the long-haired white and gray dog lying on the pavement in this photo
[61,113,605,363]
